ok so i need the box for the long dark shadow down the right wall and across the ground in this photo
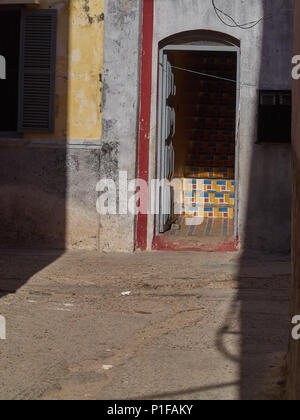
[217,0,292,400]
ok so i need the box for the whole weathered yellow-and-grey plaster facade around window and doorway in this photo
[0,0,292,251]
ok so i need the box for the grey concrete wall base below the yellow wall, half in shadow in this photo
[0,139,108,249]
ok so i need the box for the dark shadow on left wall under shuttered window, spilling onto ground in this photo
[0,2,69,297]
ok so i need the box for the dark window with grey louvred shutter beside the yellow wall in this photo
[0,8,57,136]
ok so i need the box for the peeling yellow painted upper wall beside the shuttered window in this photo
[27,0,104,140]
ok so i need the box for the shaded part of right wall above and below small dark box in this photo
[244,0,293,253]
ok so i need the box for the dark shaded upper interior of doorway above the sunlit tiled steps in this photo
[170,51,236,178]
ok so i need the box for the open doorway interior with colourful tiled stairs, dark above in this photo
[164,50,237,238]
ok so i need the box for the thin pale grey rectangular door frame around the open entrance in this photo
[155,45,241,237]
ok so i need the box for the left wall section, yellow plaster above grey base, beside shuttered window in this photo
[0,0,105,249]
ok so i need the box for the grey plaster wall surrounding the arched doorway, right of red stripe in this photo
[148,0,292,251]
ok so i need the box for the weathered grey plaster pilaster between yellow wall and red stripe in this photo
[100,0,142,252]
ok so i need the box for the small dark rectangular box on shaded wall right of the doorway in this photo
[257,90,292,143]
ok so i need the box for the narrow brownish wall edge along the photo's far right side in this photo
[287,0,300,400]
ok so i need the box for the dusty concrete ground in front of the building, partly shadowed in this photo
[0,251,290,400]
